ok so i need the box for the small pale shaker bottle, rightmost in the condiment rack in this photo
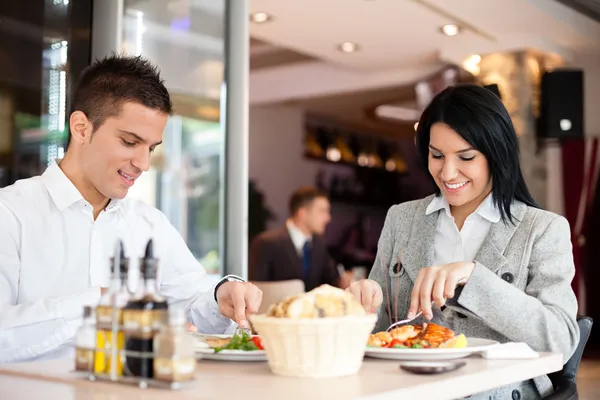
[154,308,196,382]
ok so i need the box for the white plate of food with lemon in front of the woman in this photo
[365,323,499,361]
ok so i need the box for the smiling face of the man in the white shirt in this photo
[81,102,168,199]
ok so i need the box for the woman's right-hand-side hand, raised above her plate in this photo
[407,261,475,319]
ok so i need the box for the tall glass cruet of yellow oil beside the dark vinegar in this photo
[94,241,130,378]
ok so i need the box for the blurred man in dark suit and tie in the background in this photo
[248,187,341,291]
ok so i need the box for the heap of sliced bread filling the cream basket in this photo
[267,285,366,319]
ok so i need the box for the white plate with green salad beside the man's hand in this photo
[194,331,267,361]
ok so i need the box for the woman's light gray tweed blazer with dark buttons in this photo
[369,195,579,400]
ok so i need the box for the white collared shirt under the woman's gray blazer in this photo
[425,193,500,265]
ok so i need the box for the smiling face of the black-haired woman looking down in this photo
[428,122,492,213]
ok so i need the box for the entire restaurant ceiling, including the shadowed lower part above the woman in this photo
[250,0,600,131]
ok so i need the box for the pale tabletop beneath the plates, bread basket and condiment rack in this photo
[0,353,563,400]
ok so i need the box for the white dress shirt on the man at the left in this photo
[0,163,235,363]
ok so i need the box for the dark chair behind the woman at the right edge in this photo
[544,315,594,400]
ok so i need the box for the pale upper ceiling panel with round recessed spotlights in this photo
[250,0,600,71]
